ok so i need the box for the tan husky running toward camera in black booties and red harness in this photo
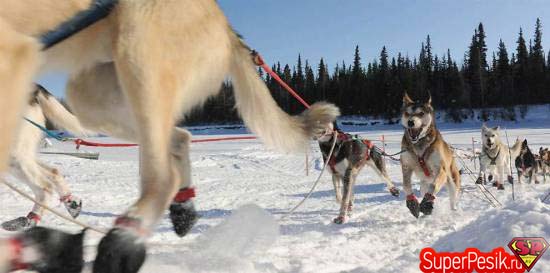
[401,93,460,218]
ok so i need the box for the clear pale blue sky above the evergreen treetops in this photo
[38,0,550,96]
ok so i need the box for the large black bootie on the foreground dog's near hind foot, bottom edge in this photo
[93,228,146,273]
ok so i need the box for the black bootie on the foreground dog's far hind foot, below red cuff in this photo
[170,200,199,237]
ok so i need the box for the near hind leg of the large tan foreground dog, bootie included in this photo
[93,51,181,273]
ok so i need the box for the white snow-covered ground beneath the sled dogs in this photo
[0,116,550,273]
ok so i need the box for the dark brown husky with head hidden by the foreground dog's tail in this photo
[318,124,399,224]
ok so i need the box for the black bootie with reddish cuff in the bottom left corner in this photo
[11,227,85,273]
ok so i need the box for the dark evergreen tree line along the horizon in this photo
[184,19,550,125]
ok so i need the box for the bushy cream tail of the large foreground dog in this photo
[230,41,340,152]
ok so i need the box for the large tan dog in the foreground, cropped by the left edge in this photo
[0,0,339,273]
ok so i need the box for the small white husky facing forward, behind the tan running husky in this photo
[476,124,521,190]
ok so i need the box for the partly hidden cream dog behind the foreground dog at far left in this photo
[2,85,87,231]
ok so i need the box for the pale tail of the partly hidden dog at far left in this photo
[35,85,93,136]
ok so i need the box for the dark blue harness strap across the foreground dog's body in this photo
[40,0,118,50]
